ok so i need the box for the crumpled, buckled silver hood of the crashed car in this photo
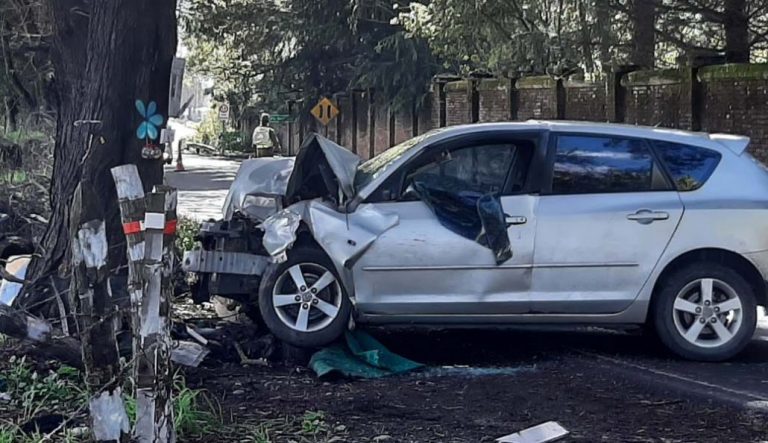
[223,134,360,220]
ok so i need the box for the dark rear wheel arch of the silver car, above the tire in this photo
[651,248,768,306]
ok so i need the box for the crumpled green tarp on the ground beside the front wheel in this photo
[309,330,424,378]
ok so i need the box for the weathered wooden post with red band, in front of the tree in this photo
[112,165,176,443]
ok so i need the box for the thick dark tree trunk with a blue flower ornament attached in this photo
[19,0,176,313]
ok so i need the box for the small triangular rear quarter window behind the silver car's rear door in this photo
[653,141,720,191]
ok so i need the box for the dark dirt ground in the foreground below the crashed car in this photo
[186,331,768,442]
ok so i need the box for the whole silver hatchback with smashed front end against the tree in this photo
[184,121,768,360]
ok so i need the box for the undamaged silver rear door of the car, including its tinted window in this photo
[531,134,683,314]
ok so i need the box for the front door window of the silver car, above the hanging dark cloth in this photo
[404,143,517,193]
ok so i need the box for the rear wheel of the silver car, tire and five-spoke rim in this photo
[651,262,757,361]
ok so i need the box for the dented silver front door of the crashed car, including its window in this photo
[353,133,543,321]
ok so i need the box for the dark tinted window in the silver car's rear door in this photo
[552,135,669,194]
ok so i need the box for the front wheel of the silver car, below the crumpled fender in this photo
[259,247,352,348]
